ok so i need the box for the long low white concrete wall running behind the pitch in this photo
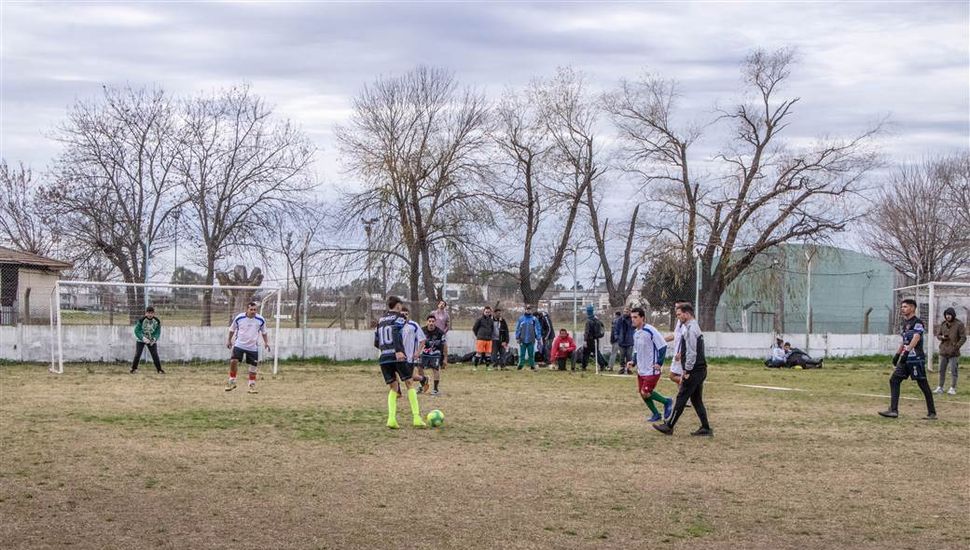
[0,325,899,362]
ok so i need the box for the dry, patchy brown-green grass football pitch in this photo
[0,362,970,550]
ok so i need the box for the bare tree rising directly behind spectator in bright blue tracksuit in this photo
[492,69,601,304]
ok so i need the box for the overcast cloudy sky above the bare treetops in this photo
[0,1,970,185]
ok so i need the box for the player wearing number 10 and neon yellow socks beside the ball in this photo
[374,296,426,430]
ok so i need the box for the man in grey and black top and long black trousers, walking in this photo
[653,303,714,437]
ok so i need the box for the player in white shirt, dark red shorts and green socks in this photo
[626,307,673,422]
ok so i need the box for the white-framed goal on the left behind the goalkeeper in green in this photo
[50,281,281,374]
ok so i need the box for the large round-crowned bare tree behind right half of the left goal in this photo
[175,86,314,326]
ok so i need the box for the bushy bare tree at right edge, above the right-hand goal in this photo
[863,156,970,282]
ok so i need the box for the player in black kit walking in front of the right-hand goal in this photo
[879,298,936,420]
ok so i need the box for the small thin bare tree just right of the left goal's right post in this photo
[269,205,329,327]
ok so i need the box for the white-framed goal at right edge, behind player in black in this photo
[892,283,970,370]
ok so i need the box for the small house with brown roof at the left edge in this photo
[0,246,72,325]
